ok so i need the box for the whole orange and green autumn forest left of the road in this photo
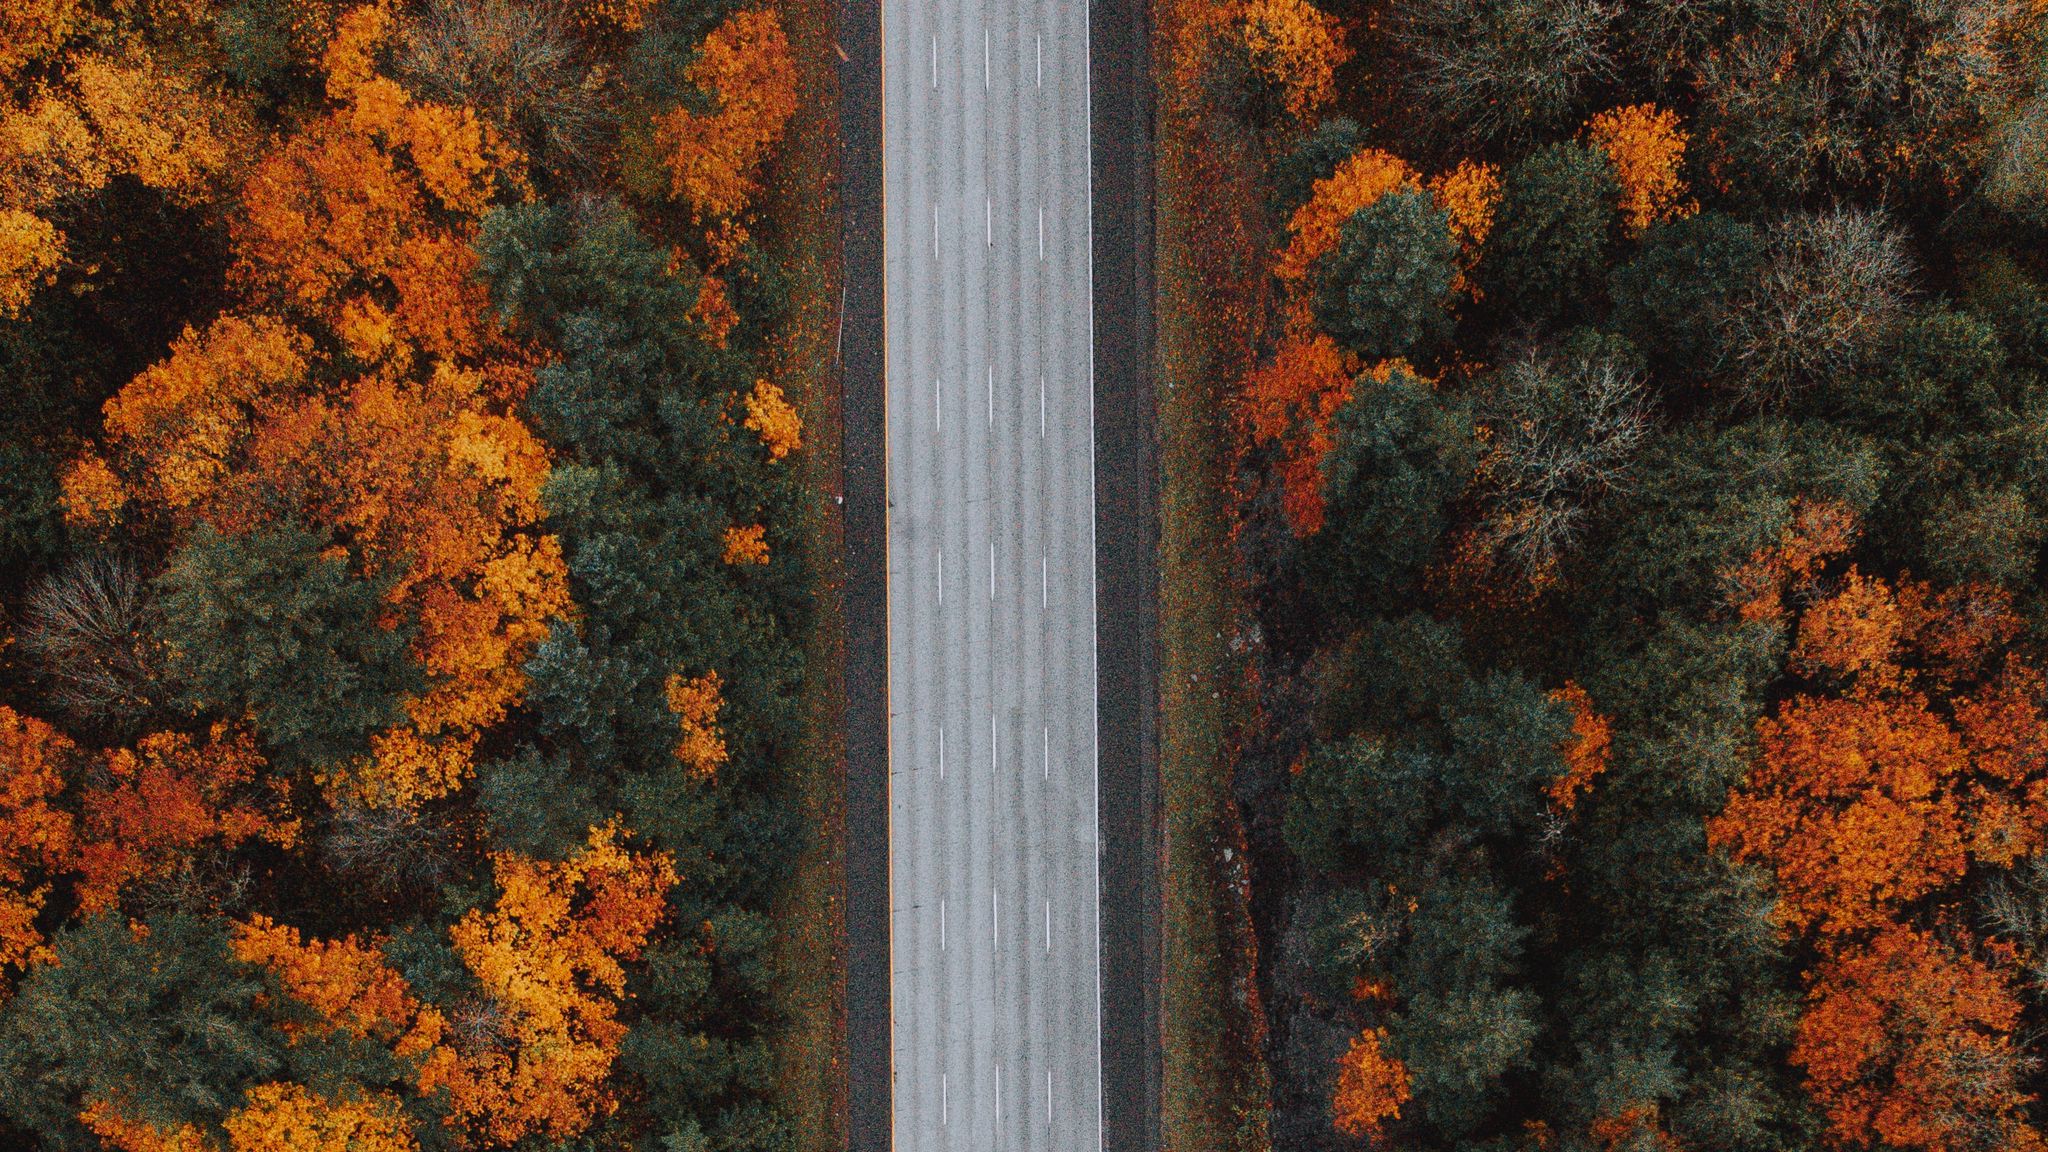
[0,0,817,1152]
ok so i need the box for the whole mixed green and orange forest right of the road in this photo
[1187,0,2048,1152]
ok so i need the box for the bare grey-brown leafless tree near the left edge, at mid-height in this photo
[20,558,164,726]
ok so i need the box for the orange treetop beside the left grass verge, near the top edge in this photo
[653,8,797,221]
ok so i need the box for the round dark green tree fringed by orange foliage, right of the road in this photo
[1315,189,1458,361]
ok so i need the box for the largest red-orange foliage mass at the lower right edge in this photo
[1708,561,2048,1152]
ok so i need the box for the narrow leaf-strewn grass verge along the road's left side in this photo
[762,0,846,1152]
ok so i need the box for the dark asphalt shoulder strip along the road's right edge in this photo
[1087,0,1161,1131]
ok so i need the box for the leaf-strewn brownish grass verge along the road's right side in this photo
[1153,0,1272,1152]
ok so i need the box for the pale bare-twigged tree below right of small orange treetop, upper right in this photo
[1729,209,1913,404]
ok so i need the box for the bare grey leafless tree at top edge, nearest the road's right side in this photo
[1395,0,1614,137]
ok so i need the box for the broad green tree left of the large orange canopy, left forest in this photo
[158,523,422,765]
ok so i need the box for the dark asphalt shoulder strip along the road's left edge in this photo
[838,0,895,1131]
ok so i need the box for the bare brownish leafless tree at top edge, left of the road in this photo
[399,0,608,166]
